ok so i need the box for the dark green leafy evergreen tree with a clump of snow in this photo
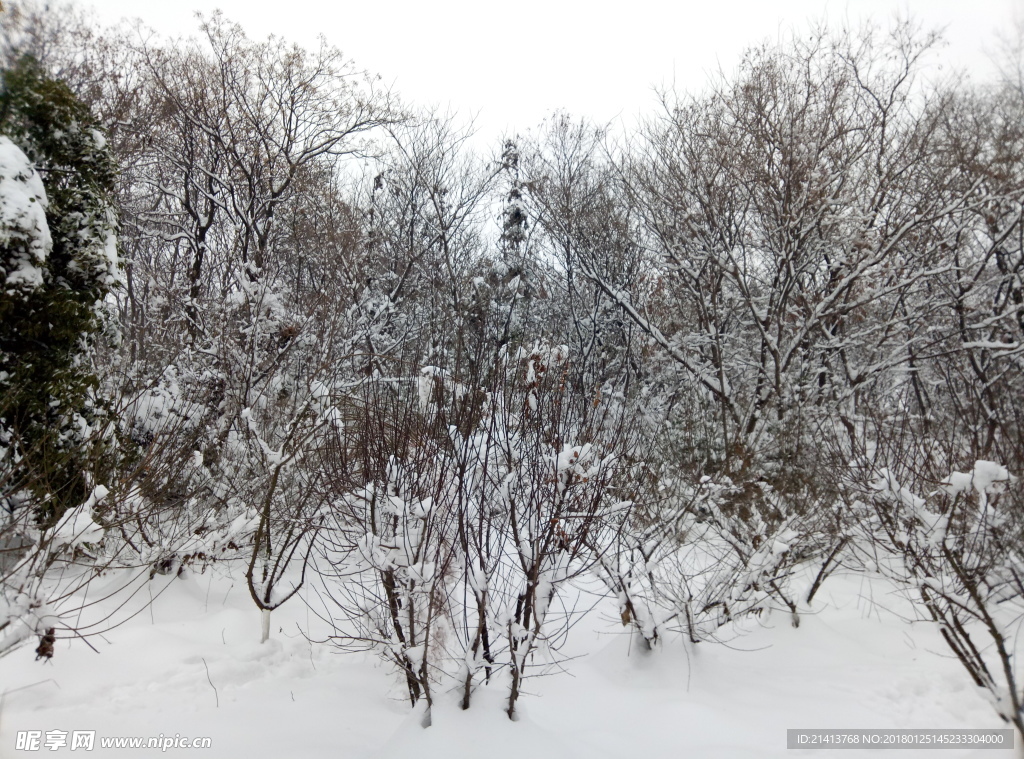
[0,56,121,526]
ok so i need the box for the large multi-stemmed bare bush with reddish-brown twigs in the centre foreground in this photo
[321,343,632,717]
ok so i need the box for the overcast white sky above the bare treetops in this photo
[83,0,1024,145]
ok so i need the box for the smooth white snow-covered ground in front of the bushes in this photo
[0,565,1014,759]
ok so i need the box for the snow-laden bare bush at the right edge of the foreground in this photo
[854,461,1024,730]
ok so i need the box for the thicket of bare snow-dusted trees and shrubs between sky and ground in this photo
[0,1,1024,728]
